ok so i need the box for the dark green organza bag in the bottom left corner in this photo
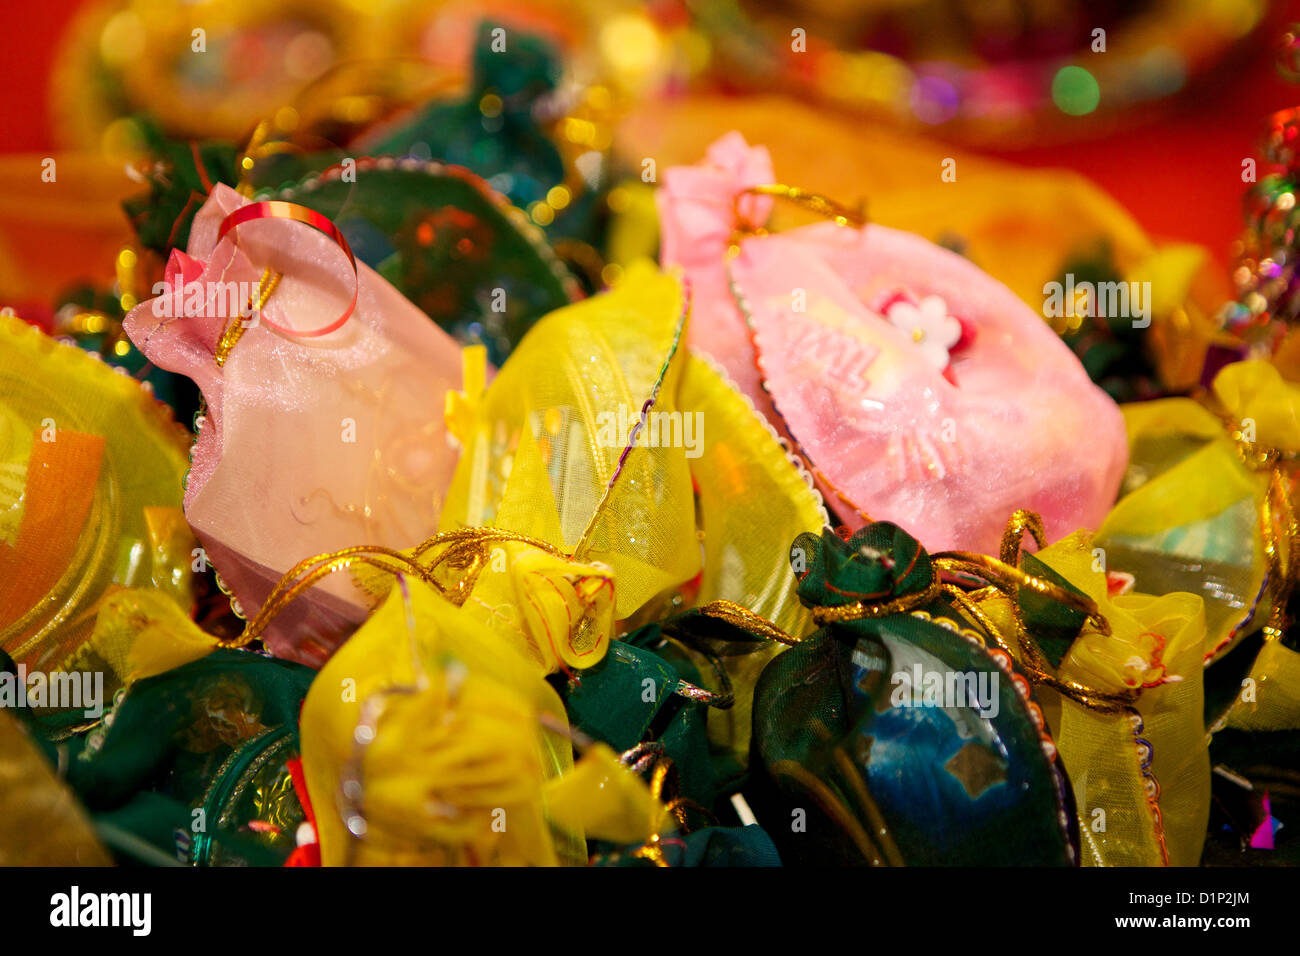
[26,650,315,866]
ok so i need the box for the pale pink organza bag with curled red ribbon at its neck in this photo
[126,185,462,666]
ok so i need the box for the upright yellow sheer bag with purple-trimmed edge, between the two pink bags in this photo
[439,265,699,618]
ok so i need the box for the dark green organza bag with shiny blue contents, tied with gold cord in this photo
[655,523,1082,865]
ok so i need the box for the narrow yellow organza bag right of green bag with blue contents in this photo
[982,532,1210,866]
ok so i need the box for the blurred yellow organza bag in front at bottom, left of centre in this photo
[302,579,660,866]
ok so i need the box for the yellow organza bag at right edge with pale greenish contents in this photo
[1093,360,1300,732]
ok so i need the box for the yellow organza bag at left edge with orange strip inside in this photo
[0,316,195,670]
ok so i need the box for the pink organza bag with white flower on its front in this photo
[658,133,1127,554]
